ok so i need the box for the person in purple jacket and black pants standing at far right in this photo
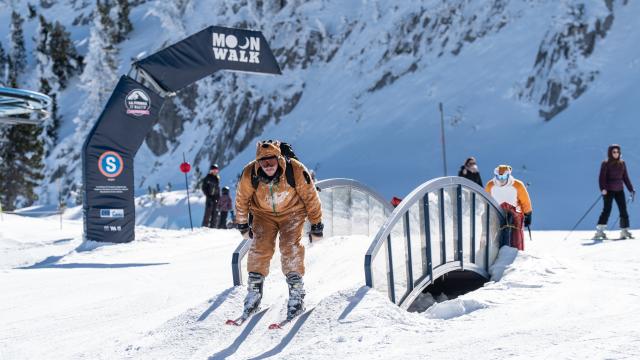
[594,144,636,240]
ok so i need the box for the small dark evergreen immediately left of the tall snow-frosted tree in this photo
[48,21,83,90]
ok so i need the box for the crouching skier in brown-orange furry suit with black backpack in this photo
[236,140,323,319]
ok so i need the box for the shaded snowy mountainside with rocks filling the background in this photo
[0,0,640,229]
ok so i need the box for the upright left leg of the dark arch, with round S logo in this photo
[82,76,164,243]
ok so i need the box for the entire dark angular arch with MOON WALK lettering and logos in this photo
[82,26,281,243]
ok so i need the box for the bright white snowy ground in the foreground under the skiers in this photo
[0,215,640,360]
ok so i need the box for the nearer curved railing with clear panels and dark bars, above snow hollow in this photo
[364,176,505,309]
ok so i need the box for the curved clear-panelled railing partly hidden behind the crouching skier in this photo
[231,178,393,286]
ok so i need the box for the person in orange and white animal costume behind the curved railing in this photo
[486,165,533,250]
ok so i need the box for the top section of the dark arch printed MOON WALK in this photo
[135,26,281,91]
